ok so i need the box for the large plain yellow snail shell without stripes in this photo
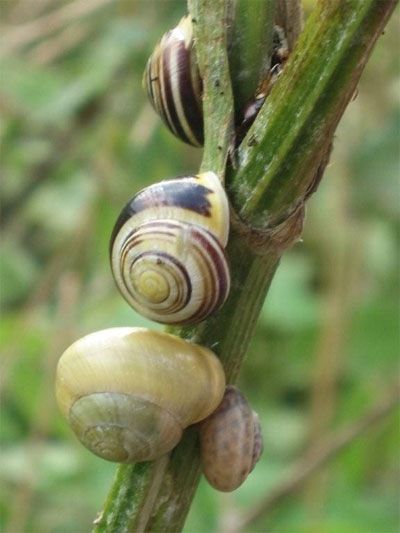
[56,327,225,463]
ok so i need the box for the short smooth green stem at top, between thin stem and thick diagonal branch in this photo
[229,0,275,116]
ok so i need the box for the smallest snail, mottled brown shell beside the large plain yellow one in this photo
[199,386,263,492]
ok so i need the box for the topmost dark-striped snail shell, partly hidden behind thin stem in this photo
[143,15,203,146]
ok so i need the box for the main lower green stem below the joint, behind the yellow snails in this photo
[95,232,280,533]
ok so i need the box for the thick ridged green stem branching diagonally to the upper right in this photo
[229,0,396,227]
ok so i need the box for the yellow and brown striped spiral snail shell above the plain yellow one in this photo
[110,172,230,325]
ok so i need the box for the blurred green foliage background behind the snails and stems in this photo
[0,0,400,533]
